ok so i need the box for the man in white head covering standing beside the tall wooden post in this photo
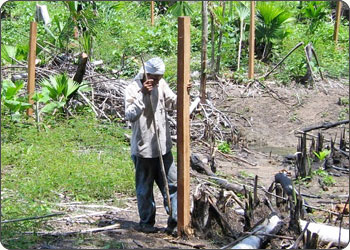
[125,57,182,233]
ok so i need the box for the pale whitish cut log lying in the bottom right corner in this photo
[299,220,349,247]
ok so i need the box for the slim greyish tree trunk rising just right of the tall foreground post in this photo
[200,1,208,103]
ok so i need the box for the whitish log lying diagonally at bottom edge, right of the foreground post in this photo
[231,213,283,249]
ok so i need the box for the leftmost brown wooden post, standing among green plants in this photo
[27,22,36,116]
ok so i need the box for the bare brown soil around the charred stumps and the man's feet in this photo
[35,79,349,249]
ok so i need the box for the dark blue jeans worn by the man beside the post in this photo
[131,152,177,226]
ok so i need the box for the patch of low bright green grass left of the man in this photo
[1,114,135,246]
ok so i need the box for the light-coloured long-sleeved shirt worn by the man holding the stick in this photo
[125,79,177,158]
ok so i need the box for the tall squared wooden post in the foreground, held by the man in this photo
[177,16,191,235]
